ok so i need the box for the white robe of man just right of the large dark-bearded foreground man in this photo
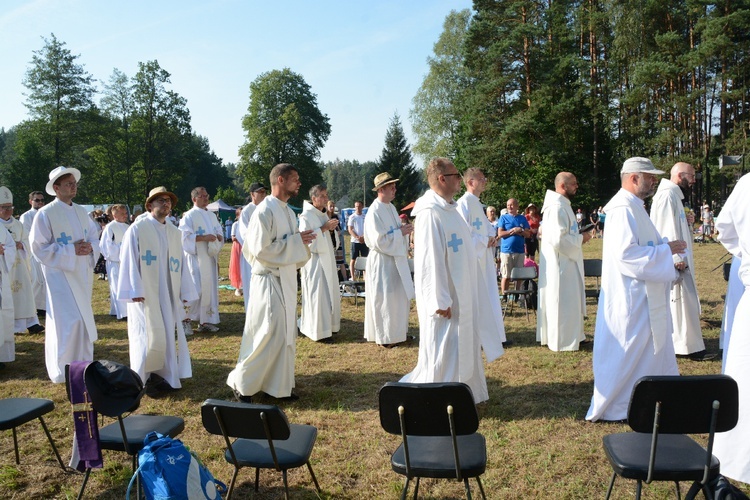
[299,201,341,340]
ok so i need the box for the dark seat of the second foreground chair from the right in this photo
[391,434,487,479]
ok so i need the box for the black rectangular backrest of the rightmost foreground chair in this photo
[628,375,739,434]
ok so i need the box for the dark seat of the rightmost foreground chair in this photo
[603,432,719,481]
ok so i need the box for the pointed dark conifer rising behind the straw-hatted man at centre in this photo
[370,113,425,209]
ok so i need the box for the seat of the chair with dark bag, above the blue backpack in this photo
[99,415,185,452]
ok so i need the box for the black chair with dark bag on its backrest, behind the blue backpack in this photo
[65,360,185,500]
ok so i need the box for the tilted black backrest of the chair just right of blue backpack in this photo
[201,399,291,440]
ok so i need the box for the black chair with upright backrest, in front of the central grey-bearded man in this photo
[379,382,487,500]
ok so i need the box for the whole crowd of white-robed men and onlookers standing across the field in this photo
[0,157,750,482]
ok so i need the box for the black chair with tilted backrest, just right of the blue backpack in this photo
[201,399,320,500]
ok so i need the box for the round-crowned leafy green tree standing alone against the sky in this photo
[237,68,331,204]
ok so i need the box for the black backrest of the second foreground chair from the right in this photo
[379,382,479,436]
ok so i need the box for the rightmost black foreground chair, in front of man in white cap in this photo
[603,375,739,500]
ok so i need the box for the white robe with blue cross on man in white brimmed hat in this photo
[29,199,99,383]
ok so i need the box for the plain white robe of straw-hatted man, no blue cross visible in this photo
[364,198,414,345]
